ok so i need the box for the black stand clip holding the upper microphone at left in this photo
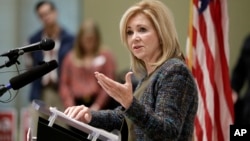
[0,50,24,69]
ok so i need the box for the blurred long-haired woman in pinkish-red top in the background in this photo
[60,20,116,110]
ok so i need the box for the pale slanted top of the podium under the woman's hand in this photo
[32,100,121,141]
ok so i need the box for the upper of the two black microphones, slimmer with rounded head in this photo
[0,39,55,57]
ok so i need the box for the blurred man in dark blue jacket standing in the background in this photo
[26,1,74,109]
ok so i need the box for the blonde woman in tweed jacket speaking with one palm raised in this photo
[64,0,198,141]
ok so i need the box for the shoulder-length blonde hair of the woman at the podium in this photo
[120,0,184,77]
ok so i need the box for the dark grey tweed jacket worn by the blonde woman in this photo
[90,58,198,141]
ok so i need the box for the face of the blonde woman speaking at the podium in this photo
[126,14,161,63]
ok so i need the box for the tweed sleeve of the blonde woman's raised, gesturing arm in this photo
[125,65,197,140]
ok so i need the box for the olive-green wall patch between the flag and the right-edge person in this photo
[228,0,250,72]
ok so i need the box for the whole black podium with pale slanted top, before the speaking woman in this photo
[30,100,121,141]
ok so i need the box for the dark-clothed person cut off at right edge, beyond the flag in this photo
[231,35,250,125]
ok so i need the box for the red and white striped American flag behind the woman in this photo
[186,0,234,141]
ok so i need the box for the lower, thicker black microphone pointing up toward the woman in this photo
[0,60,58,97]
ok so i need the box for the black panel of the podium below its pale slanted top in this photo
[37,117,89,141]
